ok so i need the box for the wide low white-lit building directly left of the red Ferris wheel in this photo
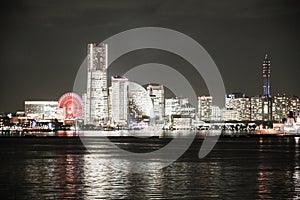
[24,101,62,120]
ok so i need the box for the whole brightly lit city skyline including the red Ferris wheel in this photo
[4,43,300,124]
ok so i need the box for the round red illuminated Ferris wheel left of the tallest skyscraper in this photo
[58,92,83,119]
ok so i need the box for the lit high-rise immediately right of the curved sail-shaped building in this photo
[147,84,165,120]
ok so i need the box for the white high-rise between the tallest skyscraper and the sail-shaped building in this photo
[110,76,128,125]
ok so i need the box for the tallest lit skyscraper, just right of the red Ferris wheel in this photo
[84,43,108,125]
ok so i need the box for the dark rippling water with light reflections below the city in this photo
[0,137,300,199]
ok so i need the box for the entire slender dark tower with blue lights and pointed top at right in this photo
[262,54,272,121]
